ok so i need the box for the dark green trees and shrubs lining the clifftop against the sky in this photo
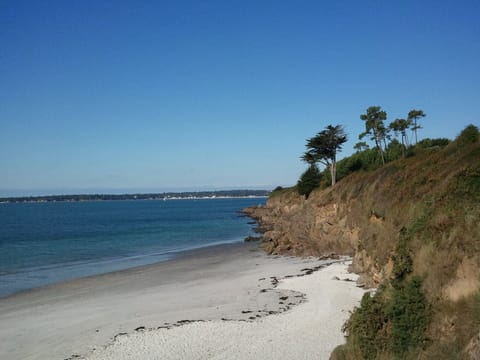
[297,106,436,197]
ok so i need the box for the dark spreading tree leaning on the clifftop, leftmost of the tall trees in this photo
[302,125,347,186]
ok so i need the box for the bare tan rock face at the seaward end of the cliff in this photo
[246,181,396,287]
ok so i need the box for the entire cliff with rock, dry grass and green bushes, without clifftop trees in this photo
[260,125,480,359]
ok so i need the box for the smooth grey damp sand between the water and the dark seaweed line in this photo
[0,243,363,360]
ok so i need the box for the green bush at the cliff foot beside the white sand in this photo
[338,225,431,359]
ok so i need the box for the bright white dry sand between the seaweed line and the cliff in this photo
[85,262,364,360]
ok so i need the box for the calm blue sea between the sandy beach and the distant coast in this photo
[0,198,265,296]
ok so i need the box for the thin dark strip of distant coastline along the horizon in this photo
[0,190,270,203]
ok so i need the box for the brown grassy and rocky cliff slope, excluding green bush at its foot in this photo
[247,137,480,358]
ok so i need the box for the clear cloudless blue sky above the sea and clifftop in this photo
[0,0,480,196]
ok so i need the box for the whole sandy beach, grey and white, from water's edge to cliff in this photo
[0,244,363,360]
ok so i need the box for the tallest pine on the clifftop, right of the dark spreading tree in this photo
[358,106,389,164]
